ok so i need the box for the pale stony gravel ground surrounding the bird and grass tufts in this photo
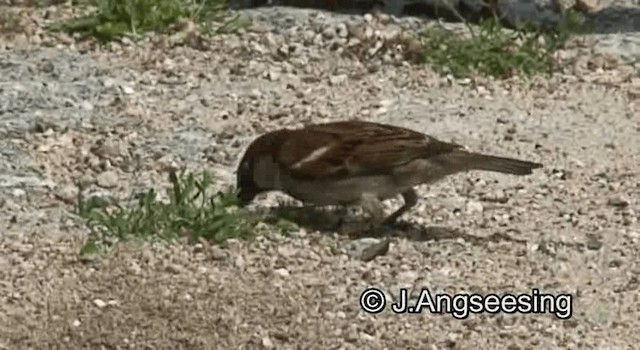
[0,3,640,349]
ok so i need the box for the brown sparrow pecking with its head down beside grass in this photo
[236,120,542,228]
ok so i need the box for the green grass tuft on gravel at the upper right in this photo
[417,12,588,78]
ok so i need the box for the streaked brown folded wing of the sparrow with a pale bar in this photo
[278,121,462,178]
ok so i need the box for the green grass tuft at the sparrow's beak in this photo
[76,172,295,256]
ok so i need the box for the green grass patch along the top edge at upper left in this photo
[51,0,247,41]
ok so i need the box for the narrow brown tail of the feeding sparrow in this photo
[444,151,542,175]
